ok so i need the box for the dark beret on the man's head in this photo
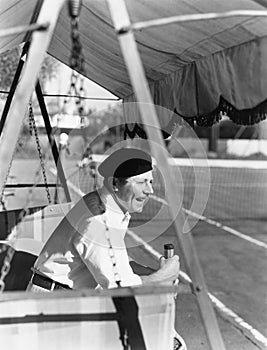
[98,148,152,178]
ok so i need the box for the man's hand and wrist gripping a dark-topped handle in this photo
[141,255,180,283]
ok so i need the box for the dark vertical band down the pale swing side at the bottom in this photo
[112,297,146,350]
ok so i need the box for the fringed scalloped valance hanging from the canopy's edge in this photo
[124,37,267,127]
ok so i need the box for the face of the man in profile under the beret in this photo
[115,171,153,213]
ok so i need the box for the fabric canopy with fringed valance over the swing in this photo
[0,0,267,125]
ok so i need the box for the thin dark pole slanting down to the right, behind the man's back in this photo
[35,80,71,202]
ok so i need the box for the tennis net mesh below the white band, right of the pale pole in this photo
[181,164,267,219]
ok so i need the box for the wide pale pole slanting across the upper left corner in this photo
[0,0,65,197]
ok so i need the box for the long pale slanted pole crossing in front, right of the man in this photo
[107,0,225,350]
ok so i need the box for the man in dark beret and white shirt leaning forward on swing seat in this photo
[28,148,180,292]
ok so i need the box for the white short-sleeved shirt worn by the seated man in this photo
[34,188,142,289]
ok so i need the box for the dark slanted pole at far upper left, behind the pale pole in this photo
[0,0,43,136]
